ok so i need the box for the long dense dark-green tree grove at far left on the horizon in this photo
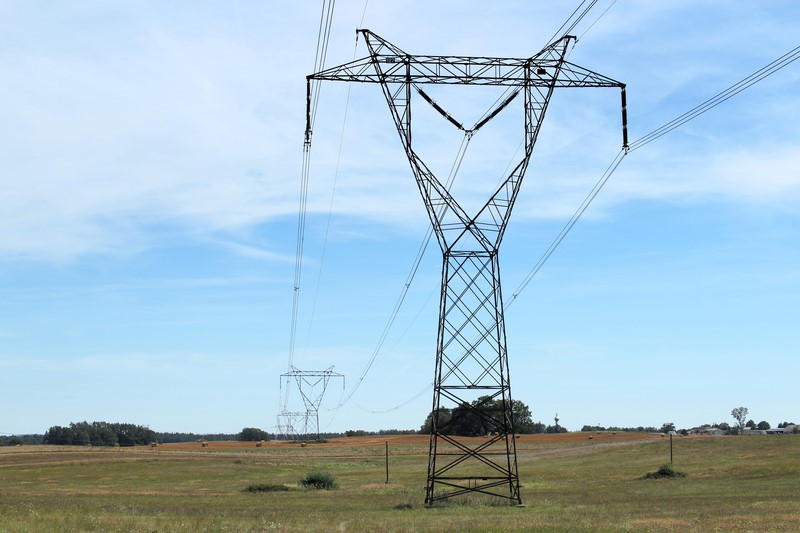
[43,422,158,446]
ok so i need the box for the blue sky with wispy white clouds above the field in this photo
[0,0,800,434]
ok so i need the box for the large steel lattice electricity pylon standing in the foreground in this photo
[306,30,628,505]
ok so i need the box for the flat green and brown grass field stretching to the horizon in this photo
[0,433,800,533]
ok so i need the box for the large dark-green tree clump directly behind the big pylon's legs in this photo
[419,396,567,437]
